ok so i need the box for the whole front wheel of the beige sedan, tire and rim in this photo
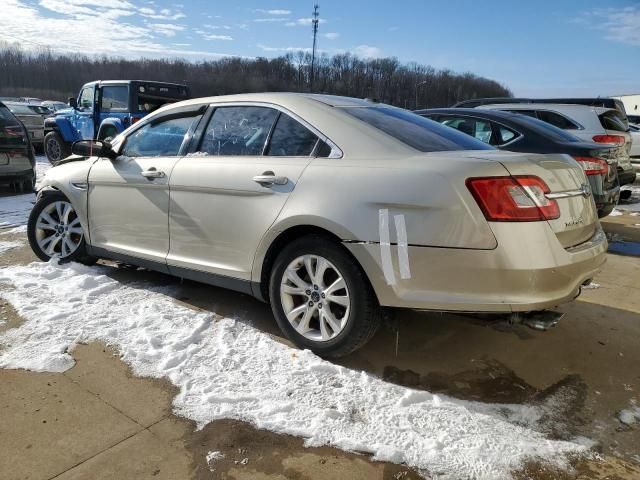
[27,193,95,264]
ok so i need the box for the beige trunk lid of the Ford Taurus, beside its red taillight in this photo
[472,152,598,248]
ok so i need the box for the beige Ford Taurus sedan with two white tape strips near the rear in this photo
[28,93,607,356]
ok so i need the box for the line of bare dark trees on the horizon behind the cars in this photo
[0,44,511,109]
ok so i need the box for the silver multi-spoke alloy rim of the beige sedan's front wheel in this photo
[35,200,84,258]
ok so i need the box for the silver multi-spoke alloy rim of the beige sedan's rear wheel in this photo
[280,255,351,342]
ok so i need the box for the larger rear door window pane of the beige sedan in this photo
[199,107,278,156]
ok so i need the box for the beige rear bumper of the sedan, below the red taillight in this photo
[345,224,607,312]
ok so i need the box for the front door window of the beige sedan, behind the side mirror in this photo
[122,115,201,157]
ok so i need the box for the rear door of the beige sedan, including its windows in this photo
[167,104,319,280]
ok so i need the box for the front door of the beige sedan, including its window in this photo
[89,110,198,264]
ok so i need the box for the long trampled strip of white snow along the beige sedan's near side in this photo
[0,260,587,479]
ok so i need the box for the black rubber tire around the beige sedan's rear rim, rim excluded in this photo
[269,234,382,357]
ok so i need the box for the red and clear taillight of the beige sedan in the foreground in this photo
[466,175,560,222]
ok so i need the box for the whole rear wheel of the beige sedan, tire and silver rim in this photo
[269,235,381,357]
